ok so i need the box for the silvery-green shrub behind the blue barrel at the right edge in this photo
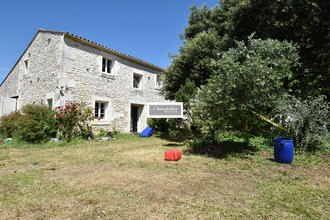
[276,96,330,151]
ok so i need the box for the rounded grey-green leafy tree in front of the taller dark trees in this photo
[195,37,298,138]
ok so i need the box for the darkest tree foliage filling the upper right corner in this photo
[222,0,330,98]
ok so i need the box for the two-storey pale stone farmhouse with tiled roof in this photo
[0,29,165,133]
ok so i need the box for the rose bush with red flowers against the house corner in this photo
[55,102,94,141]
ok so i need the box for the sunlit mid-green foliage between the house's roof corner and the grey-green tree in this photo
[164,32,223,100]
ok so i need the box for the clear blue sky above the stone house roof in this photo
[0,0,218,82]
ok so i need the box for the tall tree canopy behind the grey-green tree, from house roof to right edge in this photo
[165,0,330,98]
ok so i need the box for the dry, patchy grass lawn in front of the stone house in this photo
[0,135,330,219]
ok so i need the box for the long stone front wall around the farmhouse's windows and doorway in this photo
[63,38,165,132]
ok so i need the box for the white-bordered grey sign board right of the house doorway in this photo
[147,102,183,118]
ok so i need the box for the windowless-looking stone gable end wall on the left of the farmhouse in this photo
[0,32,63,115]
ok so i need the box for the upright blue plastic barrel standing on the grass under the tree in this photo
[274,137,293,164]
